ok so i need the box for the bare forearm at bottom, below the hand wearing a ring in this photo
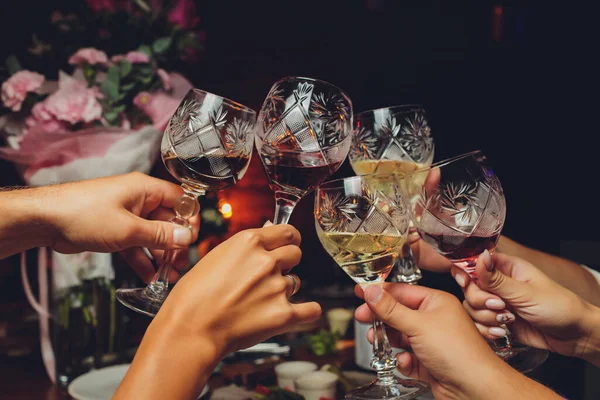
[113,313,221,400]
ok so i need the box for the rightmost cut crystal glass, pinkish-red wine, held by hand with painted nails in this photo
[403,150,548,372]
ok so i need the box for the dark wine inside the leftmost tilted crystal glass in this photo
[163,152,250,191]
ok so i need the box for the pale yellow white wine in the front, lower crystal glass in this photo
[317,227,406,284]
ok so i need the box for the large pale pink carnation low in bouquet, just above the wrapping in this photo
[45,74,102,124]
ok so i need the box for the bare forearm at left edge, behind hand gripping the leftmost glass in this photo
[0,189,52,259]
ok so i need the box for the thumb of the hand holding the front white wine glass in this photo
[364,284,418,337]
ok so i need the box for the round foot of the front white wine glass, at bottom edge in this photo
[344,376,431,400]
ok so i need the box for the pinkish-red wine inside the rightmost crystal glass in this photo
[421,232,500,273]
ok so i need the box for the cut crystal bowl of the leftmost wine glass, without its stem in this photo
[161,89,256,195]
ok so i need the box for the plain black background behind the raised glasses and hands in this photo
[0,0,600,399]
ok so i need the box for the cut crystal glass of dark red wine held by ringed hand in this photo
[255,77,353,224]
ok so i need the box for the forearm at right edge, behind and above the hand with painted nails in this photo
[497,236,600,306]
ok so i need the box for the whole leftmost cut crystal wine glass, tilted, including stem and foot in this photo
[116,89,256,316]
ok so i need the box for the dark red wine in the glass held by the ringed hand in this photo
[261,152,344,197]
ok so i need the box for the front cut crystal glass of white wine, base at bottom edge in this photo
[315,174,429,399]
